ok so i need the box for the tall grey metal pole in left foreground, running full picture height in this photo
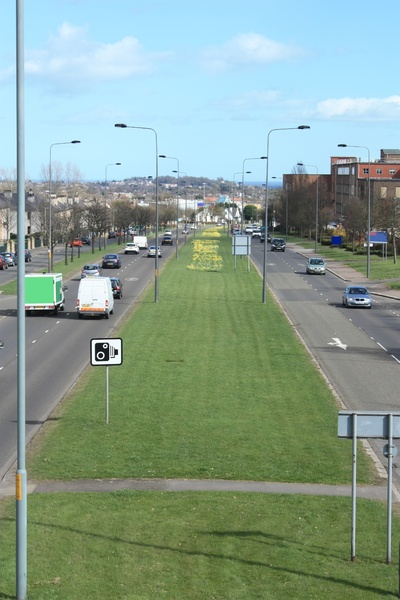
[16,0,27,600]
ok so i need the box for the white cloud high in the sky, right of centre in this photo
[201,33,304,71]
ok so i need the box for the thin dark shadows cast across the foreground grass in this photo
[0,518,393,599]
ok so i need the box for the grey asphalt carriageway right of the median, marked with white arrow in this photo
[252,243,400,489]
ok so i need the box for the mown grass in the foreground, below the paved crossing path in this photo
[0,492,399,600]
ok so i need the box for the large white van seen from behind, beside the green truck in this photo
[76,277,114,319]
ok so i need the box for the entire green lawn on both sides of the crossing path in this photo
[0,231,400,600]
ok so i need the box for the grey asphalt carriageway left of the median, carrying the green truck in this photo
[0,240,175,481]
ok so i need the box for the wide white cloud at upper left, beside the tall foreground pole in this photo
[25,23,170,88]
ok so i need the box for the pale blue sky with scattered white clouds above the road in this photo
[0,0,400,184]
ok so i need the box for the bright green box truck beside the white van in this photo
[25,273,67,315]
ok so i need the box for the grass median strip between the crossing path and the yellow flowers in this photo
[29,230,372,484]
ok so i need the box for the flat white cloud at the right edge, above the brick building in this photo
[317,96,400,121]
